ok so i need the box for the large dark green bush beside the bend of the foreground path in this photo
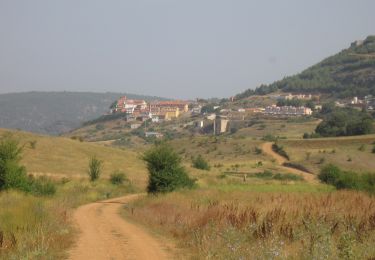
[142,143,195,193]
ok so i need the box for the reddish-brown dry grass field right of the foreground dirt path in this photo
[127,189,375,259]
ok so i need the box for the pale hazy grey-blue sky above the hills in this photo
[0,0,375,98]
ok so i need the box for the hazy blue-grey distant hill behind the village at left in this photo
[0,92,166,135]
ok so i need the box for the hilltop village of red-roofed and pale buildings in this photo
[102,93,374,138]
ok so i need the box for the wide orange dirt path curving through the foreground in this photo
[69,194,171,260]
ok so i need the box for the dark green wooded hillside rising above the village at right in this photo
[236,36,375,99]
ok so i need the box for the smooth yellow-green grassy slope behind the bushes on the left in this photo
[0,129,147,186]
